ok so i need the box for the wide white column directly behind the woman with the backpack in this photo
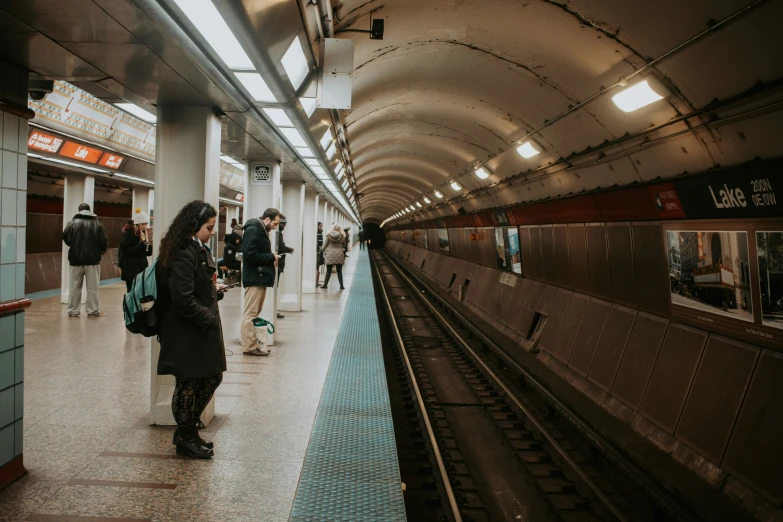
[148,106,221,425]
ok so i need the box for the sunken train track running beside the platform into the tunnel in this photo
[373,252,696,522]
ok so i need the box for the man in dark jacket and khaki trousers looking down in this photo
[241,208,280,356]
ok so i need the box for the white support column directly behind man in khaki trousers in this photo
[245,160,284,346]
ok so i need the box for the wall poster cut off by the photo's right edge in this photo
[756,231,783,329]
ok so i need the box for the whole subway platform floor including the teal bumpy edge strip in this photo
[0,249,405,522]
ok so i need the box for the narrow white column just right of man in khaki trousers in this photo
[279,181,305,312]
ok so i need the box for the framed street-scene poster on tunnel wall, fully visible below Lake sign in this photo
[666,230,753,322]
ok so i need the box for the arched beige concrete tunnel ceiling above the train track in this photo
[332,0,783,222]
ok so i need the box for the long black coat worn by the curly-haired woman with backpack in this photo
[157,240,226,377]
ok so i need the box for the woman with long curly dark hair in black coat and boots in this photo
[156,201,226,459]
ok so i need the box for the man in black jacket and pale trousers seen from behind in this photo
[62,203,109,317]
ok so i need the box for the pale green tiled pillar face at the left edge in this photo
[0,62,27,466]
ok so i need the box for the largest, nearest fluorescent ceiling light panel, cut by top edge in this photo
[174,0,255,70]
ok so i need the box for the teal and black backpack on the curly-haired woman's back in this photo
[122,259,162,337]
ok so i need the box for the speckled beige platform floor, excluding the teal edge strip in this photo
[0,251,359,522]
